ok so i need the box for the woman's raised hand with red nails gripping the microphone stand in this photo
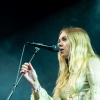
[20,63,39,89]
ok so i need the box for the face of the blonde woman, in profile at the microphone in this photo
[58,31,70,59]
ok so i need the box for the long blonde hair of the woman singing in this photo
[54,27,97,95]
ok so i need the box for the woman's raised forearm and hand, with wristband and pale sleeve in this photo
[20,63,53,100]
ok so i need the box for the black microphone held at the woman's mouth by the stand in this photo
[26,42,60,52]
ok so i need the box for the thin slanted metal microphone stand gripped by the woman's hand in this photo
[7,47,40,100]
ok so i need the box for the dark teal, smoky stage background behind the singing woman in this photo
[0,0,100,100]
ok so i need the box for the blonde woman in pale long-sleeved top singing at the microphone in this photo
[20,27,100,100]
